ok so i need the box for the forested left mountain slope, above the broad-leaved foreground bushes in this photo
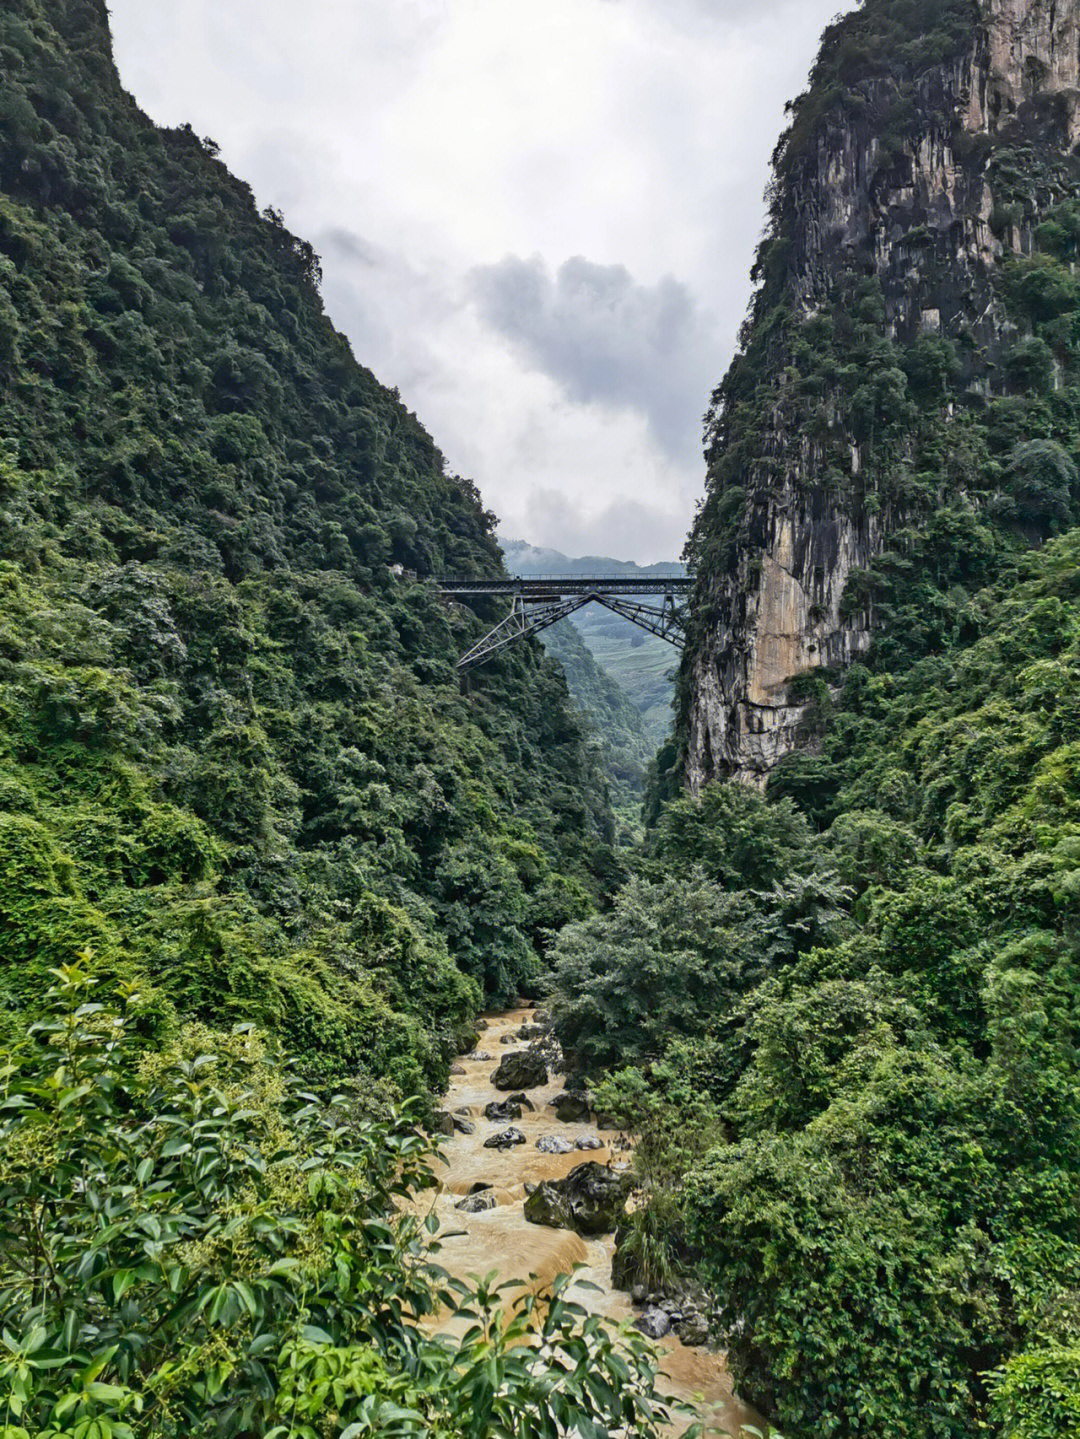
[0,0,611,1088]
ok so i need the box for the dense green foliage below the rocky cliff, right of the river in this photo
[552,530,1080,1439]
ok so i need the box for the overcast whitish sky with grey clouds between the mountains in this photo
[111,0,851,561]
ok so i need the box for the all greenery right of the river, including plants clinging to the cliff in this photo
[551,0,1080,1439]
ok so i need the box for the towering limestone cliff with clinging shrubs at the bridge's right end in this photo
[680,0,1080,787]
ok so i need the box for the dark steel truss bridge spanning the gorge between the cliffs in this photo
[437,574,693,673]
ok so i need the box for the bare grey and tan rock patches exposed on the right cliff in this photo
[680,0,1080,790]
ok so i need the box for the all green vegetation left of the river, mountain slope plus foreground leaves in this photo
[0,0,693,1439]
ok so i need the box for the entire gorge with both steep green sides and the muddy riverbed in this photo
[0,0,1080,1439]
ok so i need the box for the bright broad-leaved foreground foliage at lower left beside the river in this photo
[0,966,684,1439]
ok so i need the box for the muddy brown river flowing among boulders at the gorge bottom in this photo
[425,1007,768,1436]
